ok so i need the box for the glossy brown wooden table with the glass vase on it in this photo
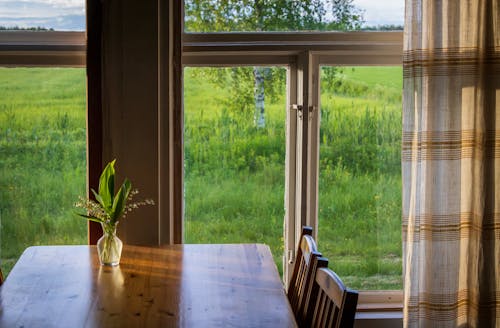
[0,244,296,328]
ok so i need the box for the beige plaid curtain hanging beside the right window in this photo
[402,0,500,327]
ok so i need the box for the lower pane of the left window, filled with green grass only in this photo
[0,68,87,273]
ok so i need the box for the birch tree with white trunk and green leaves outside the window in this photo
[185,0,363,128]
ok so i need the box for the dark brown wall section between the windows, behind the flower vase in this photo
[98,0,159,245]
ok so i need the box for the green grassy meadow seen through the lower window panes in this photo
[0,67,402,289]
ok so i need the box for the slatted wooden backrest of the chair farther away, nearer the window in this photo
[287,227,321,324]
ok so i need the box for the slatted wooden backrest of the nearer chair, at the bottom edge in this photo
[305,268,358,328]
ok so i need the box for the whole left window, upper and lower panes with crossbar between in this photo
[0,0,87,274]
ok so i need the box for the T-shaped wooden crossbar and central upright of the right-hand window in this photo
[184,32,401,288]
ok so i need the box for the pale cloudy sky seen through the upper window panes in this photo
[0,0,404,31]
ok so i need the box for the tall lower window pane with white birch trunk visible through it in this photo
[184,67,286,271]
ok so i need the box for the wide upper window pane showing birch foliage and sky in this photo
[184,0,404,32]
